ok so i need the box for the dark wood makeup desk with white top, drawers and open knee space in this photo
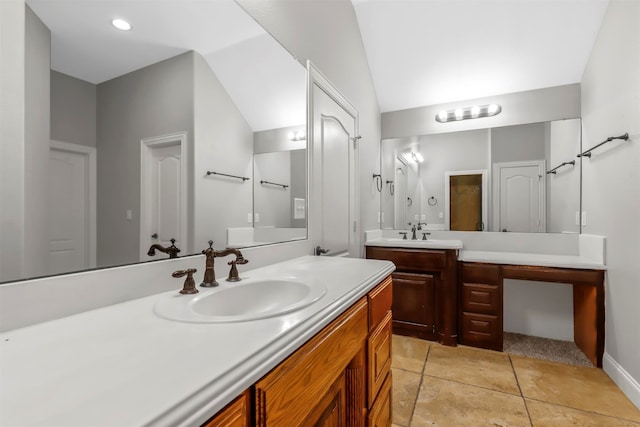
[458,250,605,367]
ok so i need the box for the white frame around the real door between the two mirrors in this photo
[307,60,362,257]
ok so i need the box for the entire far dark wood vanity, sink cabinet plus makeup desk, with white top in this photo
[366,231,606,367]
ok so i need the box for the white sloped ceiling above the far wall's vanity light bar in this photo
[352,0,608,112]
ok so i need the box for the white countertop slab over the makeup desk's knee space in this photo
[458,250,607,270]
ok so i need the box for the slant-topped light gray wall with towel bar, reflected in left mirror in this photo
[190,53,253,251]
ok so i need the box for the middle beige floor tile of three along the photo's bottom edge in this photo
[411,376,531,427]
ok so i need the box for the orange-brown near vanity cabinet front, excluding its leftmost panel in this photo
[254,277,393,427]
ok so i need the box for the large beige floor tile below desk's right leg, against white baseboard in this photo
[512,356,640,422]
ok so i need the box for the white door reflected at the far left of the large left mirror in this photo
[47,141,95,274]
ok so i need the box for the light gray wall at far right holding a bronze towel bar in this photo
[582,0,640,407]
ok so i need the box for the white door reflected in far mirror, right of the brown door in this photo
[494,161,546,232]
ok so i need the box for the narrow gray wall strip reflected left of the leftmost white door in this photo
[24,7,51,277]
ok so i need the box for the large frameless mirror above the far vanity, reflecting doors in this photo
[380,119,581,233]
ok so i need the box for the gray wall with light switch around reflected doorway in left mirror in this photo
[97,52,194,266]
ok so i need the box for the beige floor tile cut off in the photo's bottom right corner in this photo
[526,399,640,427]
